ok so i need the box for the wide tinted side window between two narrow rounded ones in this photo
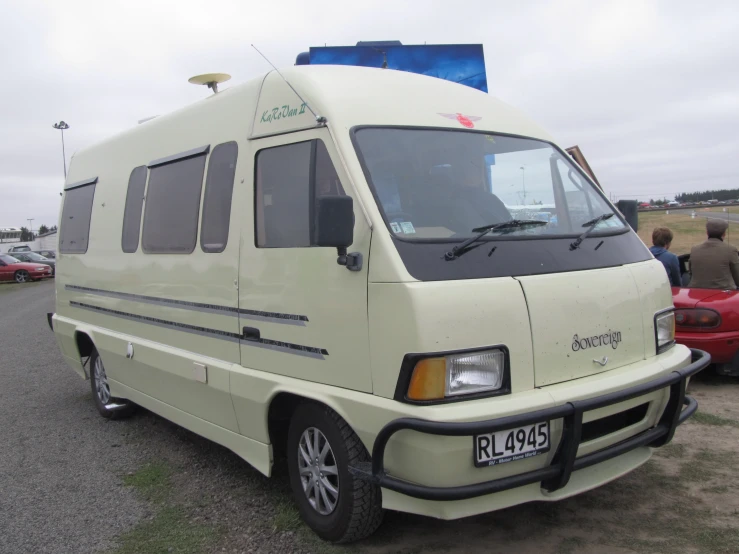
[141,151,207,254]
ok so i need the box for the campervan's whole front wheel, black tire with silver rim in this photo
[287,403,384,543]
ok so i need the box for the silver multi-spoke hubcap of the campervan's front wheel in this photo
[298,427,339,516]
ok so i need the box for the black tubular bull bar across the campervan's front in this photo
[350,349,711,501]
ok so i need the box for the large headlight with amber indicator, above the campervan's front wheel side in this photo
[407,348,506,401]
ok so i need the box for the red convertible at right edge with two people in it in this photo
[672,255,739,377]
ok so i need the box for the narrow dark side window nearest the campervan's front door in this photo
[200,142,239,252]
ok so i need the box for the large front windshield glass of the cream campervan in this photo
[356,128,625,241]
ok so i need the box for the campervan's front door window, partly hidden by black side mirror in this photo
[255,140,345,248]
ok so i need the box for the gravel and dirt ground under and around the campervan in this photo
[0,282,739,554]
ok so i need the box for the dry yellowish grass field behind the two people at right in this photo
[638,208,739,255]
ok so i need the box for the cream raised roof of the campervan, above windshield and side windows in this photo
[75,65,552,164]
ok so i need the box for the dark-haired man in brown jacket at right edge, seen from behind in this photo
[690,219,739,290]
